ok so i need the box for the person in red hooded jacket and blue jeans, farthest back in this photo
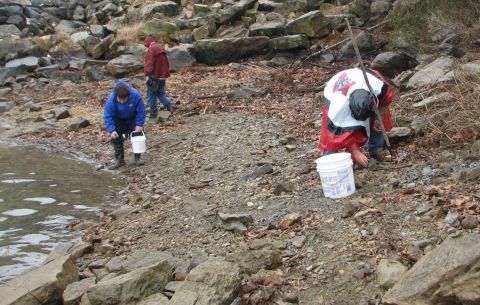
[143,36,172,118]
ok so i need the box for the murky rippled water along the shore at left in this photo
[0,145,119,284]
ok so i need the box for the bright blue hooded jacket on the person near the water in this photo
[103,80,146,133]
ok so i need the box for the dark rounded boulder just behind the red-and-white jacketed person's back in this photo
[371,51,417,77]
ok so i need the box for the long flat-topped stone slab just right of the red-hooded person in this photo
[193,36,269,64]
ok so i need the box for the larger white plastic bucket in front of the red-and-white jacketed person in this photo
[315,153,355,199]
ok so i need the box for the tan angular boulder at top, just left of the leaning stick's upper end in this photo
[285,11,329,37]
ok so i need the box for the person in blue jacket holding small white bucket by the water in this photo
[103,80,146,169]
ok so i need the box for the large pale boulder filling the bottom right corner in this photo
[383,233,480,305]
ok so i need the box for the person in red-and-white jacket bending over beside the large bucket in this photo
[319,68,394,166]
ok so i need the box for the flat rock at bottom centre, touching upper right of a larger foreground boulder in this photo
[225,250,282,274]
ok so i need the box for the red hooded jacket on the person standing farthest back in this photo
[143,36,170,79]
